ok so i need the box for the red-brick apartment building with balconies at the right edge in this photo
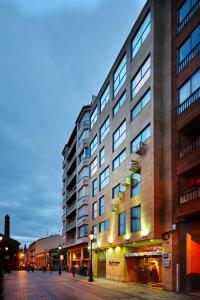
[171,0,200,292]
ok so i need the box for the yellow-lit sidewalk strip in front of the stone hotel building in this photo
[74,275,200,300]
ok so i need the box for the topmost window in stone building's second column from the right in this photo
[113,54,126,97]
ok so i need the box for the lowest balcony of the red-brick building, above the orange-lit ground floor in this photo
[177,187,200,217]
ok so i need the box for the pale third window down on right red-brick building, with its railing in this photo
[178,69,200,113]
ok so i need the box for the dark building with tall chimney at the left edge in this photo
[0,215,20,272]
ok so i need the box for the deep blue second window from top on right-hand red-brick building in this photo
[178,25,200,64]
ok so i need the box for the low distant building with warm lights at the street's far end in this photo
[27,235,63,270]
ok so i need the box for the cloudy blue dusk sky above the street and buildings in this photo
[0,0,146,245]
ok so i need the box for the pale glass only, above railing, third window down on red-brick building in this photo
[178,69,200,105]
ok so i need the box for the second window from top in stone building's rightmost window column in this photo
[131,56,151,99]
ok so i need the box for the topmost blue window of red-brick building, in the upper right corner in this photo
[177,0,200,31]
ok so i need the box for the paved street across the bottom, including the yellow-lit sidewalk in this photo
[0,271,198,300]
